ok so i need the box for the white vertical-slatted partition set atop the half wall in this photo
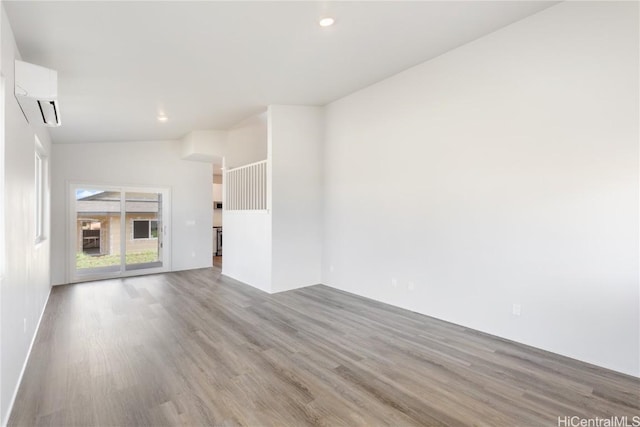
[223,160,267,211]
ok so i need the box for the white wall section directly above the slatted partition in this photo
[224,112,267,169]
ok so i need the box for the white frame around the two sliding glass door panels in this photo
[66,181,171,283]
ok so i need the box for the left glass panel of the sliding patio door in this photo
[74,188,121,276]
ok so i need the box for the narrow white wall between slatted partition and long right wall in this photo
[268,105,324,292]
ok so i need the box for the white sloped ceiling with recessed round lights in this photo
[3,1,555,142]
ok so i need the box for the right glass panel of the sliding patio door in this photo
[125,192,162,270]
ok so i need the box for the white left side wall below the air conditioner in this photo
[0,7,53,425]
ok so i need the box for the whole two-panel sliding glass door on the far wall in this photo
[69,184,170,282]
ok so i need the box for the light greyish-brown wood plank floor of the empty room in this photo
[9,268,640,426]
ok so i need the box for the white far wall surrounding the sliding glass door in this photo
[52,141,213,285]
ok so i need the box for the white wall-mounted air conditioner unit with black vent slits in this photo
[15,60,61,127]
